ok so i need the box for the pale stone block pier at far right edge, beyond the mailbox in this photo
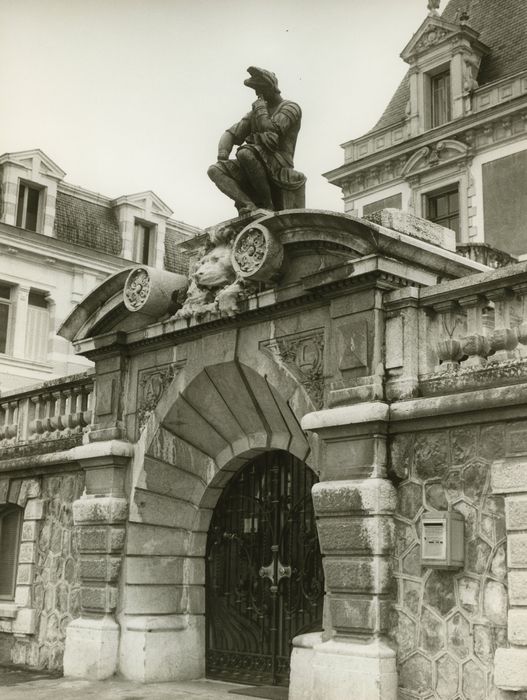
[491,459,527,700]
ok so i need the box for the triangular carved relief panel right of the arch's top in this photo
[260,328,324,408]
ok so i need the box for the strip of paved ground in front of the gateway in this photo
[0,667,252,700]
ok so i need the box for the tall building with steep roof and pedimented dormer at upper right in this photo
[326,0,527,264]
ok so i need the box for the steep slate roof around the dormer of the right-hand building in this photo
[370,0,527,131]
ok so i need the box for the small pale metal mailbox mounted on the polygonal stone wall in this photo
[421,510,465,569]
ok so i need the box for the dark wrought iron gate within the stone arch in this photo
[206,451,324,685]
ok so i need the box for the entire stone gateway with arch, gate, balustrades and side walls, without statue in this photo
[0,205,527,700]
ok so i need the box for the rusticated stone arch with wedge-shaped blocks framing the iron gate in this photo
[120,361,313,682]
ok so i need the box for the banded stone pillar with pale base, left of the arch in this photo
[64,443,129,680]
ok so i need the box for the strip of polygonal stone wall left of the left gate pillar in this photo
[12,472,84,670]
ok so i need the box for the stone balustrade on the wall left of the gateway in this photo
[0,373,93,448]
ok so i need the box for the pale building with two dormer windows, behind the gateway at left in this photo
[0,150,200,391]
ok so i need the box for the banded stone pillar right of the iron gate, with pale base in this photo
[290,402,397,700]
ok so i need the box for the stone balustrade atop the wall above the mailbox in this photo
[385,263,527,399]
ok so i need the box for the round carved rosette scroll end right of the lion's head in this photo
[232,224,284,282]
